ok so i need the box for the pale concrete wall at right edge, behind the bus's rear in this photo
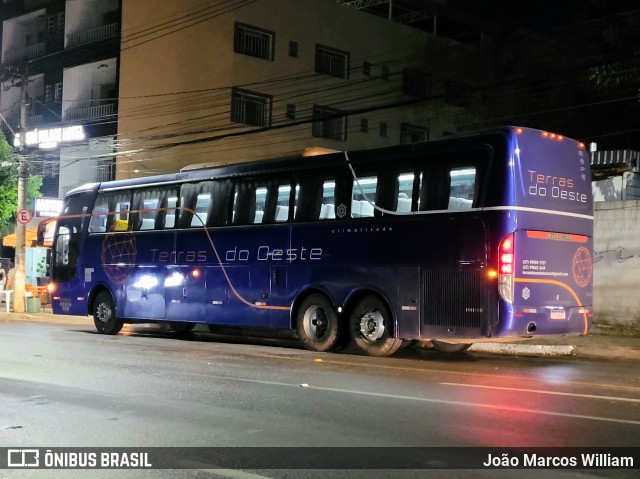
[593,200,640,329]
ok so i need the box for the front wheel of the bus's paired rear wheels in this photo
[296,294,340,352]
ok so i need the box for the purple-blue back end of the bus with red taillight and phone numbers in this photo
[495,128,593,336]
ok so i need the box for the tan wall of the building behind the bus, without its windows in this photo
[116,0,490,178]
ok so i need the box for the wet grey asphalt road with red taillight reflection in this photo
[0,321,640,478]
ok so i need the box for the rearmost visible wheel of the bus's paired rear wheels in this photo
[349,295,403,357]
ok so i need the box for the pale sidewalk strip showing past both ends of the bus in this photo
[0,310,640,361]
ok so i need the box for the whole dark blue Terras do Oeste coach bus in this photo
[45,127,593,356]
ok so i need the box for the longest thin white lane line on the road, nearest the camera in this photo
[172,373,640,426]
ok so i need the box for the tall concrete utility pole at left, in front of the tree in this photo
[13,65,29,313]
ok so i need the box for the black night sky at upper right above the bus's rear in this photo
[448,0,640,150]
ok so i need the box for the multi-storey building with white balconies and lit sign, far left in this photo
[0,0,121,197]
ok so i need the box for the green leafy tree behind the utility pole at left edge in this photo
[0,131,42,236]
